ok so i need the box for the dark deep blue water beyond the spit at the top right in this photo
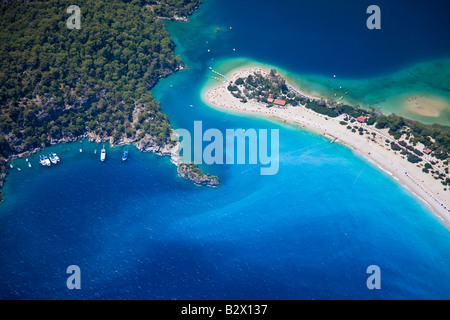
[173,0,450,79]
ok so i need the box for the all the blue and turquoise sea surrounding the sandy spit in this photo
[0,0,450,299]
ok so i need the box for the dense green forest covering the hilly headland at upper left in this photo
[0,0,200,165]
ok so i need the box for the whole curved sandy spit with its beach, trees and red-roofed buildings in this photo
[202,67,450,227]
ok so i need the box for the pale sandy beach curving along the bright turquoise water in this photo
[202,67,450,229]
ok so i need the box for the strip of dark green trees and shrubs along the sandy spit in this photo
[236,70,450,163]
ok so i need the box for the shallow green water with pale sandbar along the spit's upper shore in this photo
[208,58,450,126]
